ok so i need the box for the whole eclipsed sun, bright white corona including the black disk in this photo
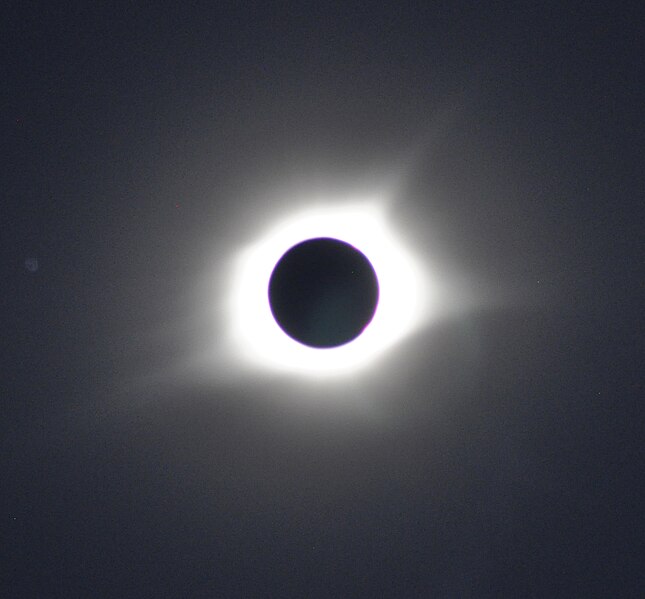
[222,199,432,378]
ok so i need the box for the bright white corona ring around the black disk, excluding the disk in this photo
[223,200,431,377]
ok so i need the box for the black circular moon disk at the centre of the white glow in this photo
[269,238,379,348]
